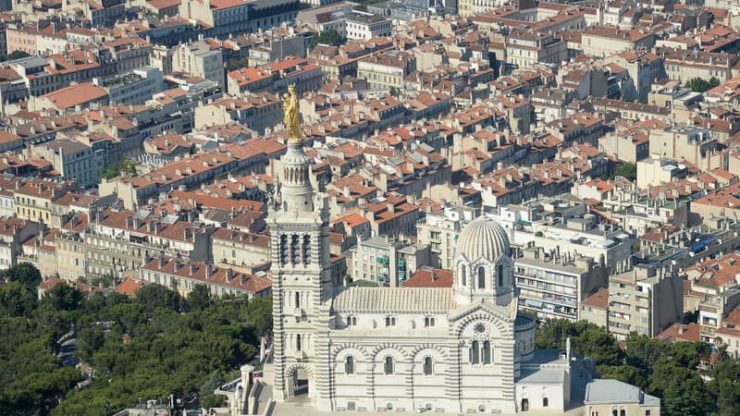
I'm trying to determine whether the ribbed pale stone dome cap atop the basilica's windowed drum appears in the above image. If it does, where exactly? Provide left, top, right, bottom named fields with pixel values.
left=457, top=214, right=511, bottom=262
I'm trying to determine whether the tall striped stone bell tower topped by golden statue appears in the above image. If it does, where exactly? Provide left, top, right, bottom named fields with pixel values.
left=268, top=87, right=334, bottom=406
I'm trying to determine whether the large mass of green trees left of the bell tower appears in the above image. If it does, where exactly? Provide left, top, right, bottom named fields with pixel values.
left=0, top=265, right=272, bottom=416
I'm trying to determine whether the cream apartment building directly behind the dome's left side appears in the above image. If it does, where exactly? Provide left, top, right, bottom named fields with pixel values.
left=416, top=206, right=478, bottom=269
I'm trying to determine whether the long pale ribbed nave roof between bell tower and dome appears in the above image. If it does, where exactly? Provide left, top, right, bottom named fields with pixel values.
left=334, top=287, right=457, bottom=313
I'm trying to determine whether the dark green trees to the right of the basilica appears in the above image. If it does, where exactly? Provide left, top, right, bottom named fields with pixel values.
left=536, top=320, right=740, bottom=416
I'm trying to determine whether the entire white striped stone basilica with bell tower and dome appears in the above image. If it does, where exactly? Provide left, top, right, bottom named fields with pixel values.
left=268, top=94, right=659, bottom=415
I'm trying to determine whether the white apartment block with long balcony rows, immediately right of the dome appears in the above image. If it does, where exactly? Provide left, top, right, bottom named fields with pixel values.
left=514, top=248, right=608, bottom=321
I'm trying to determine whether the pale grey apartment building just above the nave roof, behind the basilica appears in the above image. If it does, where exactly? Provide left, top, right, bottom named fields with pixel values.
left=350, top=237, right=432, bottom=287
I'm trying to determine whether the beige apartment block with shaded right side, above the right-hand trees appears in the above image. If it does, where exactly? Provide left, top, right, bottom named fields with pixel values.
left=608, top=268, right=683, bottom=340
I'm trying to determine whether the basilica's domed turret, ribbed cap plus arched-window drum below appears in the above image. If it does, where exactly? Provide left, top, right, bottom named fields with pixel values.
left=453, top=214, right=514, bottom=305
